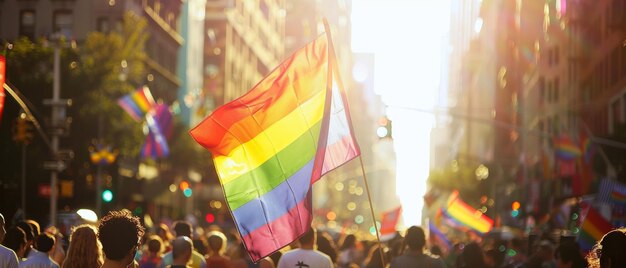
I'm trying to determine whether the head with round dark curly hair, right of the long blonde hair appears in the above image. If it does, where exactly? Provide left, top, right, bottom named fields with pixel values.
left=98, top=210, right=144, bottom=268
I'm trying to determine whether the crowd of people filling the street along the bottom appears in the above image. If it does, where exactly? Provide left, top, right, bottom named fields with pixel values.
left=0, top=210, right=626, bottom=268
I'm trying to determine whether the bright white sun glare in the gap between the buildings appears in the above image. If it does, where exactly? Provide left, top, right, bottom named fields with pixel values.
left=352, top=0, right=450, bottom=226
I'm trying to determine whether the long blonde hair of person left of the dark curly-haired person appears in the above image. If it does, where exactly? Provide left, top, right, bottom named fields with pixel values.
left=63, top=224, right=104, bottom=268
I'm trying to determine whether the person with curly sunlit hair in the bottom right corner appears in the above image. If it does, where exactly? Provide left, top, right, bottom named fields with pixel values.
left=586, top=228, right=626, bottom=268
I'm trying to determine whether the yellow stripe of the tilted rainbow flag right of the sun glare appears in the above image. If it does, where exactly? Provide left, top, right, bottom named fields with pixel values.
left=443, top=191, right=493, bottom=234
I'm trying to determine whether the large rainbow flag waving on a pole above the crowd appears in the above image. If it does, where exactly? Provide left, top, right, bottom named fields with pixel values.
left=190, top=32, right=360, bottom=262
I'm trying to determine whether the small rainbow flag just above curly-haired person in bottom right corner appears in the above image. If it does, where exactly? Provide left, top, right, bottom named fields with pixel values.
left=578, top=206, right=613, bottom=251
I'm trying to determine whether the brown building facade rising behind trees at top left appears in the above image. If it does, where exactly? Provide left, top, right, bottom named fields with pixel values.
left=0, top=0, right=183, bottom=103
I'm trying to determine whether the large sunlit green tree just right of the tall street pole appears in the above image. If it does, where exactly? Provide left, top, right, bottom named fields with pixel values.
left=72, top=12, right=148, bottom=155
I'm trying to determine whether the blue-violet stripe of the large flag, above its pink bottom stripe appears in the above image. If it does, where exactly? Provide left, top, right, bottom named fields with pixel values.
left=233, top=160, right=314, bottom=236
